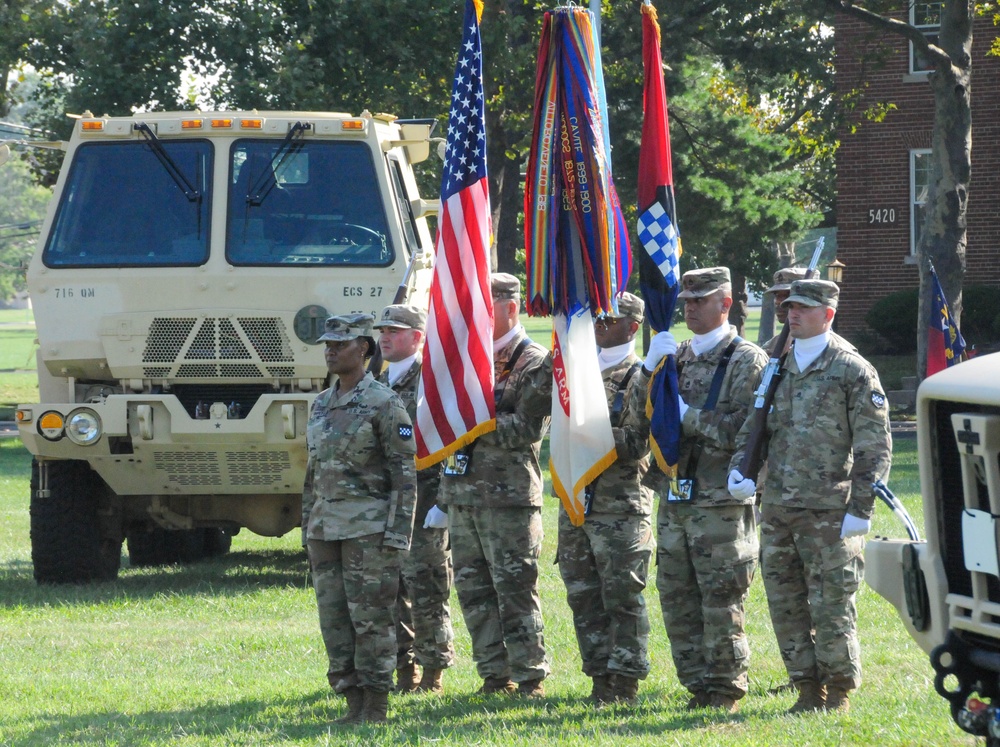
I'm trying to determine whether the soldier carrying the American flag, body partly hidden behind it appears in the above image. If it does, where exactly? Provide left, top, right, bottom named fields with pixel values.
left=438, top=273, right=552, bottom=697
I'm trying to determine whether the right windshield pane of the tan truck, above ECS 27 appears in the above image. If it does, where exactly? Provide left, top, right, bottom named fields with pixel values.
left=226, top=140, right=394, bottom=266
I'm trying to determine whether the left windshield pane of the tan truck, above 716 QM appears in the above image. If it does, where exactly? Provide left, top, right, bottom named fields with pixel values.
left=42, top=140, right=212, bottom=267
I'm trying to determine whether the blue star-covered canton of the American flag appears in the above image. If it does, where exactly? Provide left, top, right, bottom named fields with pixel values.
left=441, top=3, right=486, bottom=201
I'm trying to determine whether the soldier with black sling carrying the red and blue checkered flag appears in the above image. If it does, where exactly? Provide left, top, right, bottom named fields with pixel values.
left=640, top=267, right=767, bottom=713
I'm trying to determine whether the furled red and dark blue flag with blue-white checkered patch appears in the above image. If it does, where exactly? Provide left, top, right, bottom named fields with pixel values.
left=638, top=3, right=681, bottom=478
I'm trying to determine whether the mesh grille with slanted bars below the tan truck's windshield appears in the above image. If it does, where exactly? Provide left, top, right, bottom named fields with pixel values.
left=142, top=317, right=295, bottom=379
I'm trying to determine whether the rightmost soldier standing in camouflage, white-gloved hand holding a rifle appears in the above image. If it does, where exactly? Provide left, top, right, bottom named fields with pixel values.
left=729, top=280, right=892, bottom=713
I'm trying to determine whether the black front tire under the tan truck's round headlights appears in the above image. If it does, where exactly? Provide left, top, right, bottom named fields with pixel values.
left=30, top=459, right=122, bottom=584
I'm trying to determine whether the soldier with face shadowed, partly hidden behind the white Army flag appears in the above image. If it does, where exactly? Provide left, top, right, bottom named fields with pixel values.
left=558, top=293, right=654, bottom=706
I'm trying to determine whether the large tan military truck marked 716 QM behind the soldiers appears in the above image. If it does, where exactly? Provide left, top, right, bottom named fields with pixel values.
left=9, top=112, right=436, bottom=583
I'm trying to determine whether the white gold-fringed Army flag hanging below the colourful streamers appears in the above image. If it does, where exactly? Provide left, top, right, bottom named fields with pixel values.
left=549, top=309, right=618, bottom=526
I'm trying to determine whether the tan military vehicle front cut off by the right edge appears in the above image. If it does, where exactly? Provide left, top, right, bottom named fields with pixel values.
left=865, top=353, right=1000, bottom=747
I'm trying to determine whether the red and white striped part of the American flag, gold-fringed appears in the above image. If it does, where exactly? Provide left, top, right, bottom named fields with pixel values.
left=416, top=178, right=496, bottom=469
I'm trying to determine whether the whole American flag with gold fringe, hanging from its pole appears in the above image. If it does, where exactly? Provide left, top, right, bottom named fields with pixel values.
left=416, top=0, right=496, bottom=469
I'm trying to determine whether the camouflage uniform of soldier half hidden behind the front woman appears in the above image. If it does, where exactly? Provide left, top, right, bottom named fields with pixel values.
left=379, top=356, right=455, bottom=669
